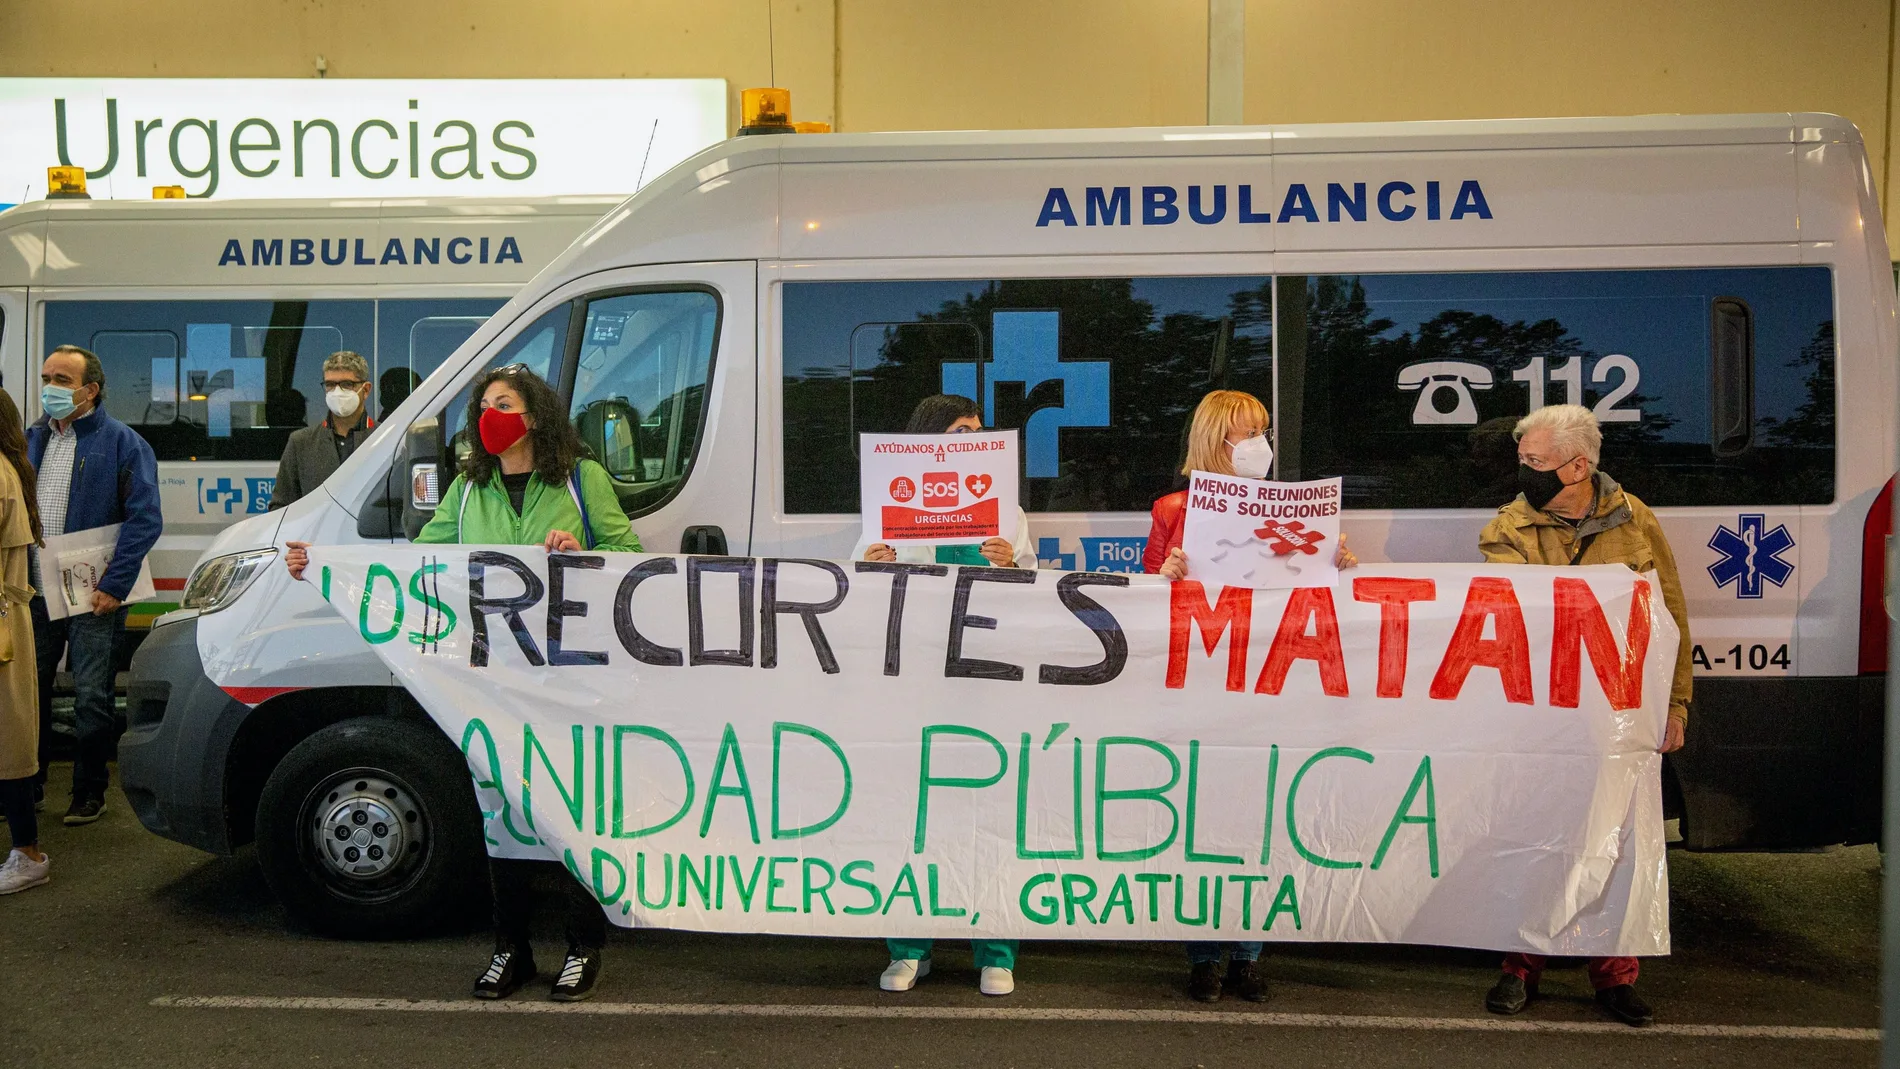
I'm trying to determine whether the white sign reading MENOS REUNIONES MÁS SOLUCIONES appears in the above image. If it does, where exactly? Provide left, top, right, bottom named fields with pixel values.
left=1182, top=471, right=1341, bottom=591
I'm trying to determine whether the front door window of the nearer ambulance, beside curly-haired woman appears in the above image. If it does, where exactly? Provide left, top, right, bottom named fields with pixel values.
left=570, top=289, right=720, bottom=516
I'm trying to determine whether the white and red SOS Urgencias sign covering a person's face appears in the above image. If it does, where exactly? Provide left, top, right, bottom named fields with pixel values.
left=857, top=431, right=1018, bottom=545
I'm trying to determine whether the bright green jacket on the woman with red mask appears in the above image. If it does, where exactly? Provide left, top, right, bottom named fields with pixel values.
left=416, top=459, right=640, bottom=553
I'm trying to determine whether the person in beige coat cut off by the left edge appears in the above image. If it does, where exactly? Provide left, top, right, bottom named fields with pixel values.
left=0, top=389, right=53, bottom=894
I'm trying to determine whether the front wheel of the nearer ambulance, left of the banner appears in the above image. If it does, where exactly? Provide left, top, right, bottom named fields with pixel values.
left=257, top=718, right=488, bottom=940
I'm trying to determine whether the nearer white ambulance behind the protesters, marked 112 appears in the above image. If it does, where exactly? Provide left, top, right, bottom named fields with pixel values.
left=122, top=114, right=1896, bottom=934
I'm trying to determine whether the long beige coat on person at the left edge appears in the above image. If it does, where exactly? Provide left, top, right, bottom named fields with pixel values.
left=0, top=458, right=40, bottom=780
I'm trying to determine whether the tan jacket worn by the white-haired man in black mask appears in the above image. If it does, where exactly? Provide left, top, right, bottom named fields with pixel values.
left=1478, top=471, right=1693, bottom=723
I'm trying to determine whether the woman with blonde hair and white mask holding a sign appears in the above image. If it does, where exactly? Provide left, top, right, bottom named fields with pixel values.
left=1142, top=389, right=1359, bottom=1003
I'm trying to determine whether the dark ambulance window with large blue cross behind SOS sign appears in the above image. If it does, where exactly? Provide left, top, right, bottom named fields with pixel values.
left=781, top=275, right=1273, bottom=515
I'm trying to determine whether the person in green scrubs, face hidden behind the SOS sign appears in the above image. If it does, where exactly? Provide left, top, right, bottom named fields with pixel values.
left=851, top=393, right=1036, bottom=995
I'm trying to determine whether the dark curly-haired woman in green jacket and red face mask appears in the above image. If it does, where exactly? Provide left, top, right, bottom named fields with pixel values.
left=285, top=365, right=640, bottom=1003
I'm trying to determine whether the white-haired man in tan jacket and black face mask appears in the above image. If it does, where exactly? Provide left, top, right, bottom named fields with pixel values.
left=1478, top=404, right=1691, bottom=1027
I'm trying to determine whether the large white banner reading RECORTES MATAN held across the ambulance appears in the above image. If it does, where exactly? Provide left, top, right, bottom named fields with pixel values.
left=310, top=545, right=1678, bottom=955
